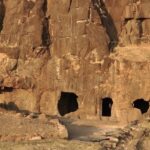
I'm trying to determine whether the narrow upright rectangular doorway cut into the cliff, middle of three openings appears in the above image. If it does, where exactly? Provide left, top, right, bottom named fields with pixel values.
left=102, top=97, right=113, bottom=117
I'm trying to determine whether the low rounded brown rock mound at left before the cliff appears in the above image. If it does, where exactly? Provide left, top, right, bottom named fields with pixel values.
left=0, top=109, right=68, bottom=142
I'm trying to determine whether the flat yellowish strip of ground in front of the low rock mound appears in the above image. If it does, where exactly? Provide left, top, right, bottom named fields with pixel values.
left=0, top=139, right=101, bottom=150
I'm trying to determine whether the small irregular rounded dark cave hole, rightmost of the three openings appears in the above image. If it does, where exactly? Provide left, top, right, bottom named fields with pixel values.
left=133, top=99, right=149, bottom=114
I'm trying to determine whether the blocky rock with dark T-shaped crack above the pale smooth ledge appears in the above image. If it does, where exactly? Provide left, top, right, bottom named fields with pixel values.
left=121, top=1, right=150, bottom=44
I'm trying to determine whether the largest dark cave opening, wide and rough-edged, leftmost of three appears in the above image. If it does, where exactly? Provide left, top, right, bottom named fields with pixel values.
left=58, top=92, right=78, bottom=116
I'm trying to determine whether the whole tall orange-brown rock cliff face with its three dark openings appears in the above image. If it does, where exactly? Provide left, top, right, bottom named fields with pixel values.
left=0, top=0, right=150, bottom=122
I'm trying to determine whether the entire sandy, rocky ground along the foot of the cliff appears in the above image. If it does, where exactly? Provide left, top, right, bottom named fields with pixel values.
left=0, top=109, right=150, bottom=150
